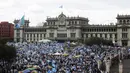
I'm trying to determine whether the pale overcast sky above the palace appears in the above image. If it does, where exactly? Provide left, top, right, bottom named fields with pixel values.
left=0, top=0, right=130, bottom=26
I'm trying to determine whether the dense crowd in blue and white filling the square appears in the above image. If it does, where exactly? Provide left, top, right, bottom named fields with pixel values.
left=1, top=41, right=126, bottom=73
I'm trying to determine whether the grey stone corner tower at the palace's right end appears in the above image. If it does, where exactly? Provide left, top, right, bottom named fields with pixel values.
left=116, top=15, right=130, bottom=46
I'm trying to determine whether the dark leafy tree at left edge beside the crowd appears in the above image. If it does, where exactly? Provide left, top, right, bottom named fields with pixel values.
left=0, top=39, right=16, bottom=73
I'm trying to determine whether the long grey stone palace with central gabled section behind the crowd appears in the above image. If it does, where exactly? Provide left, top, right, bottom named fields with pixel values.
left=14, top=13, right=130, bottom=46
